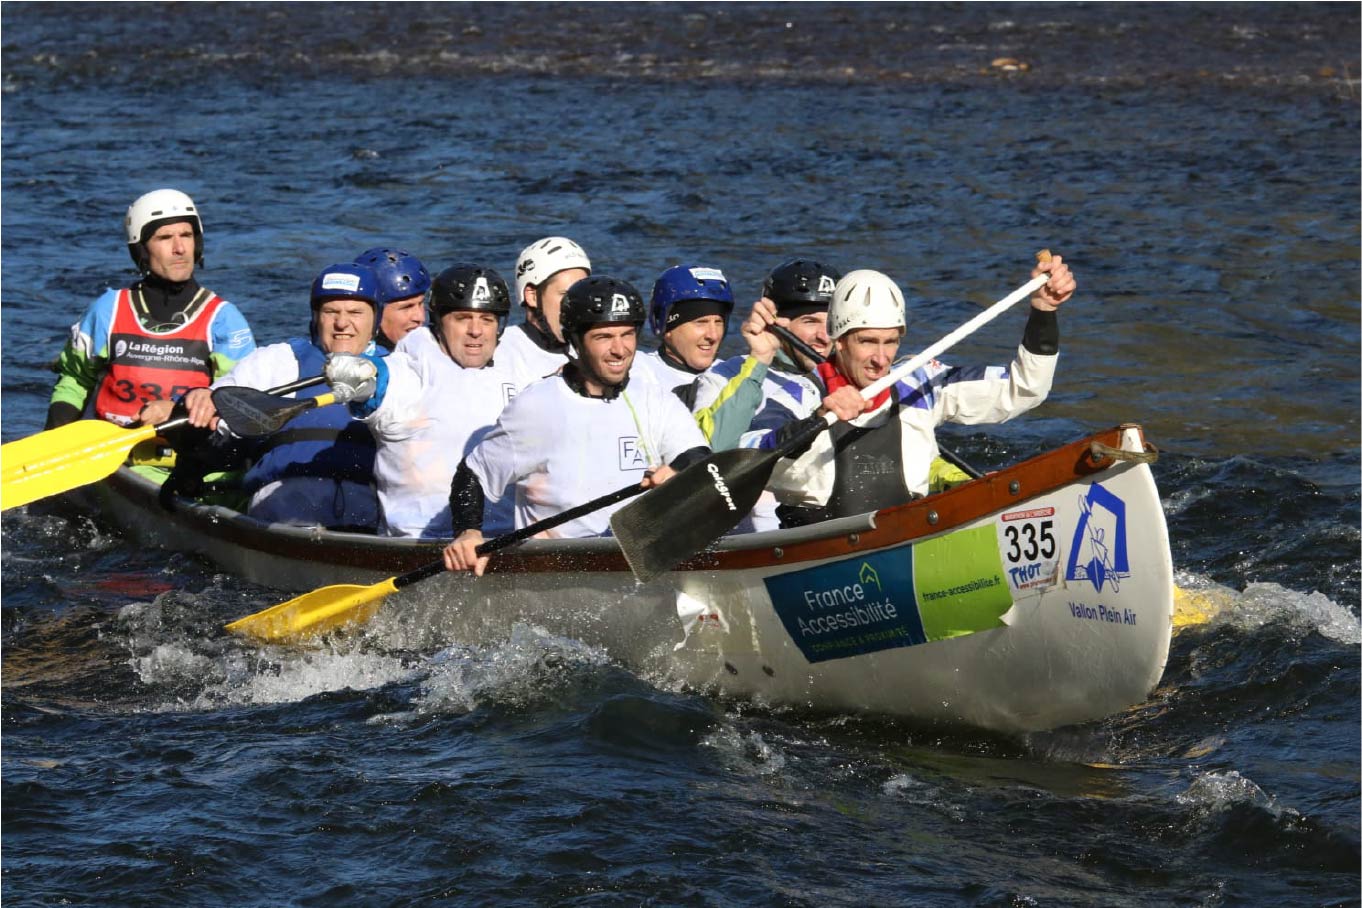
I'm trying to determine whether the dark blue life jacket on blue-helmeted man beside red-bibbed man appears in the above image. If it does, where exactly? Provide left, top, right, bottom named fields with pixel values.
left=245, top=338, right=376, bottom=491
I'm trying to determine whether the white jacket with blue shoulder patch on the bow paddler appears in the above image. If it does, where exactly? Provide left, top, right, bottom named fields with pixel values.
left=762, top=346, right=1058, bottom=508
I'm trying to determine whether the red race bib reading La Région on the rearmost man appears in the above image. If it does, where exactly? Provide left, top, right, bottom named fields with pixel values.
left=94, top=289, right=223, bottom=426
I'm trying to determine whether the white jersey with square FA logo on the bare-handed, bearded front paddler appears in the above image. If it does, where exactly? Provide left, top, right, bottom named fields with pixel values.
left=466, top=376, right=706, bottom=538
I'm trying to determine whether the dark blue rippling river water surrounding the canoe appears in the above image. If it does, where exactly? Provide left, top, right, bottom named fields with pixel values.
left=0, top=3, right=1362, bottom=905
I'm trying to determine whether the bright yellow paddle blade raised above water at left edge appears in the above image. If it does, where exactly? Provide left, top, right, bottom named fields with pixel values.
left=0, top=419, right=157, bottom=510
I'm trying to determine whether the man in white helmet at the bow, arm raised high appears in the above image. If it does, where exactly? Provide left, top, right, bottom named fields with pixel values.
left=742, top=256, right=1077, bottom=525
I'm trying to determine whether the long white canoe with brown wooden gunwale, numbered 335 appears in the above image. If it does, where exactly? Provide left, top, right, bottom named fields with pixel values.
left=85, top=425, right=1174, bottom=732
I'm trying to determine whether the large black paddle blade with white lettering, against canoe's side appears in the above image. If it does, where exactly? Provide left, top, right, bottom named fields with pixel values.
left=610, top=448, right=782, bottom=583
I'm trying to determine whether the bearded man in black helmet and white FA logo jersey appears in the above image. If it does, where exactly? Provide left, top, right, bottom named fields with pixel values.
left=444, top=276, right=710, bottom=574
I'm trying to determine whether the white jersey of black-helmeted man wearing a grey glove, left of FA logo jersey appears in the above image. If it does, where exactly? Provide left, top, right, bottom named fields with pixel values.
left=364, top=328, right=516, bottom=539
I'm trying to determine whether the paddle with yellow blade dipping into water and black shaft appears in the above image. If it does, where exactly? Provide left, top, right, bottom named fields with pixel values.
left=226, top=483, right=643, bottom=643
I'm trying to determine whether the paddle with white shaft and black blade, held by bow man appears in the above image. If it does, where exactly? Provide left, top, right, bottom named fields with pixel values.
left=610, top=266, right=1050, bottom=583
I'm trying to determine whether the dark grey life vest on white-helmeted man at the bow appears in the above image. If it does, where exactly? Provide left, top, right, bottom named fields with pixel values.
left=778, top=387, right=913, bottom=527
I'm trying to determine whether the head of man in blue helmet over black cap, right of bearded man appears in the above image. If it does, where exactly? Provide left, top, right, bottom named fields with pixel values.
left=636, top=265, right=733, bottom=407
